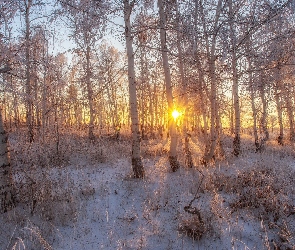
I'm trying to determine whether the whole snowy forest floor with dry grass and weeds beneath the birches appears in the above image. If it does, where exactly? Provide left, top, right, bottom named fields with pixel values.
left=0, top=133, right=295, bottom=250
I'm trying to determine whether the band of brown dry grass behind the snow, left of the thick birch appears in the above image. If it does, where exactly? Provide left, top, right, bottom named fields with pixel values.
left=9, top=129, right=135, bottom=169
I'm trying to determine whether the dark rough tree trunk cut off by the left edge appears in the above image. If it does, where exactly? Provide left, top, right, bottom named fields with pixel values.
left=0, top=110, right=15, bottom=213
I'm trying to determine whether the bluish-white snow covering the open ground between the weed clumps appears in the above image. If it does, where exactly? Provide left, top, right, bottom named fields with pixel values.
left=0, top=136, right=295, bottom=250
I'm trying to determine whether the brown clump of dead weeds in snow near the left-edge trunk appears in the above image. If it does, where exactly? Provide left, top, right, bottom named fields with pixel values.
left=14, top=167, right=78, bottom=226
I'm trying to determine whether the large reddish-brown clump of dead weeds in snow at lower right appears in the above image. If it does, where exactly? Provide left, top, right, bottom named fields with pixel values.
left=203, top=159, right=295, bottom=249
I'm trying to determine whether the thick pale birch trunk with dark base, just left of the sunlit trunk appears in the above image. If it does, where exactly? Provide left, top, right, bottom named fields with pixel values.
left=124, top=0, right=145, bottom=178
